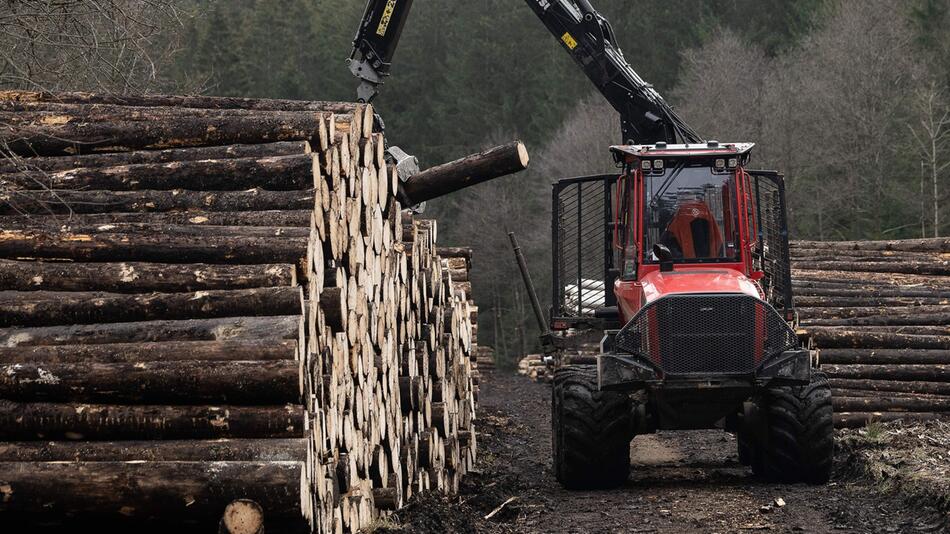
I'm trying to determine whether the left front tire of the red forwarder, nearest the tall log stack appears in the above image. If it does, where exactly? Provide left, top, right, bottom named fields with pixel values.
left=551, top=366, right=634, bottom=489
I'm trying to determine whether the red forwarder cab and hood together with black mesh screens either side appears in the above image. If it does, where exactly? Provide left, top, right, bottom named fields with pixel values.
left=551, top=141, right=793, bottom=330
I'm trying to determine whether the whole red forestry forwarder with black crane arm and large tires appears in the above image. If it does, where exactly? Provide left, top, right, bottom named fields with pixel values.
left=349, top=0, right=833, bottom=488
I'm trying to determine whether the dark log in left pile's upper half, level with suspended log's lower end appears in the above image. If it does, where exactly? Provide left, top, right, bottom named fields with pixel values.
left=0, top=189, right=313, bottom=215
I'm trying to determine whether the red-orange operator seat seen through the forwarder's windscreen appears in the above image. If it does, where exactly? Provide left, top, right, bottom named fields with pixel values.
left=660, top=200, right=723, bottom=259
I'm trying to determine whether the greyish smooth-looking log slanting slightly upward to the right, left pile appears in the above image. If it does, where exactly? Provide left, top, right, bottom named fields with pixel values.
left=0, top=315, right=300, bottom=347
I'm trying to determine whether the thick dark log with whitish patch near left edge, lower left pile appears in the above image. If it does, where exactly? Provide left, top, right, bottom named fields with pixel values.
left=0, top=360, right=301, bottom=405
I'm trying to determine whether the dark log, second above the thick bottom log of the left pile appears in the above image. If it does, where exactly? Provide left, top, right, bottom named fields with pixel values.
left=0, top=399, right=304, bottom=441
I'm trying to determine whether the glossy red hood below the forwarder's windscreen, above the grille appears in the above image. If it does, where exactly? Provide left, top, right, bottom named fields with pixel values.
left=640, top=265, right=762, bottom=304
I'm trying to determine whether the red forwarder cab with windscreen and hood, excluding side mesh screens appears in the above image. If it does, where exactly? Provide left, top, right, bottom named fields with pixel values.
left=611, top=141, right=765, bottom=321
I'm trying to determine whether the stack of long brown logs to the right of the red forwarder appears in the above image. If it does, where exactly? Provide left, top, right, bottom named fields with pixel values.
left=791, top=238, right=950, bottom=427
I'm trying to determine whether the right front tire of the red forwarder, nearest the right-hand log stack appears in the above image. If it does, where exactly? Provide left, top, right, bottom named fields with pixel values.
left=753, top=372, right=834, bottom=484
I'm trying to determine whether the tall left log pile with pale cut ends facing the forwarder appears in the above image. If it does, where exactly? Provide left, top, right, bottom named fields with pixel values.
left=0, top=92, right=527, bottom=532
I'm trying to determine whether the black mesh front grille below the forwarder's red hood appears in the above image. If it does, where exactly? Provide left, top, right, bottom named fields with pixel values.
left=616, top=294, right=798, bottom=376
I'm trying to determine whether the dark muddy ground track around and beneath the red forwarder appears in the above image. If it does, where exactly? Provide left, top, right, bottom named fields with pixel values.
left=380, top=373, right=947, bottom=533
